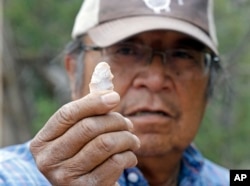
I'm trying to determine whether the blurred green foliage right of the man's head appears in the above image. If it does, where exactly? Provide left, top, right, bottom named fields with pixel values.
left=195, top=0, right=250, bottom=169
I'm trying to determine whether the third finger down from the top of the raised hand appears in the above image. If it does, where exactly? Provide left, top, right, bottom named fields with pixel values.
left=63, top=131, right=140, bottom=174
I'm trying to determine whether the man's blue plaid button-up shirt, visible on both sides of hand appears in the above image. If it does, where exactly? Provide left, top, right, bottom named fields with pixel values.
left=0, top=142, right=229, bottom=186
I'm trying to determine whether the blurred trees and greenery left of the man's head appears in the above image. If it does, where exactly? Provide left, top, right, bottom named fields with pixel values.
left=3, top=0, right=82, bottom=145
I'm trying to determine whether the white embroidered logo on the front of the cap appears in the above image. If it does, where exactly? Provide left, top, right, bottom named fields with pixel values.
left=143, top=0, right=184, bottom=14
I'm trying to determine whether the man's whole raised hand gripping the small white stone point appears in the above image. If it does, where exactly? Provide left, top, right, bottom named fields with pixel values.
left=30, top=87, right=140, bottom=186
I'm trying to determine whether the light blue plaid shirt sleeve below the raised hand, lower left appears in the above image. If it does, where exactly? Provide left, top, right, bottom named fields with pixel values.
left=0, top=142, right=49, bottom=186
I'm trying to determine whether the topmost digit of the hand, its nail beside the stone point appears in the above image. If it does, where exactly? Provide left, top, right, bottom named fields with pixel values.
left=32, top=91, right=120, bottom=142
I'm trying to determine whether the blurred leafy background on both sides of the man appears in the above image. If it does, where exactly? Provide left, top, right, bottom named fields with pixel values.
left=2, top=0, right=250, bottom=169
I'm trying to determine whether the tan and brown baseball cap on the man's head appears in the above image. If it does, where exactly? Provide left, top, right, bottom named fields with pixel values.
left=72, top=0, right=218, bottom=54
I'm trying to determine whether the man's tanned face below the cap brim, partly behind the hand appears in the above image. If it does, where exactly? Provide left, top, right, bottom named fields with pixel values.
left=68, top=31, right=208, bottom=156
